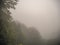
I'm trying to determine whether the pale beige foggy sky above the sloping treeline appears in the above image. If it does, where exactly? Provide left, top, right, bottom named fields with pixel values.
left=11, top=0, right=59, bottom=39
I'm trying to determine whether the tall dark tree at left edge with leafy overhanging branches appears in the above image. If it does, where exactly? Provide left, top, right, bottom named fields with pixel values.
left=0, top=0, right=17, bottom=45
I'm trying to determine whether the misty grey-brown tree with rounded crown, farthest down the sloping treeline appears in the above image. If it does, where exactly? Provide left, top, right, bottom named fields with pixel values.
left=29, top=27, right=42, bottom=45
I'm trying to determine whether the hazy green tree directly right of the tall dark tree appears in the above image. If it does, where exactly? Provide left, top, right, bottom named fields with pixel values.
left=9, top=21, right=24, bottom=45
